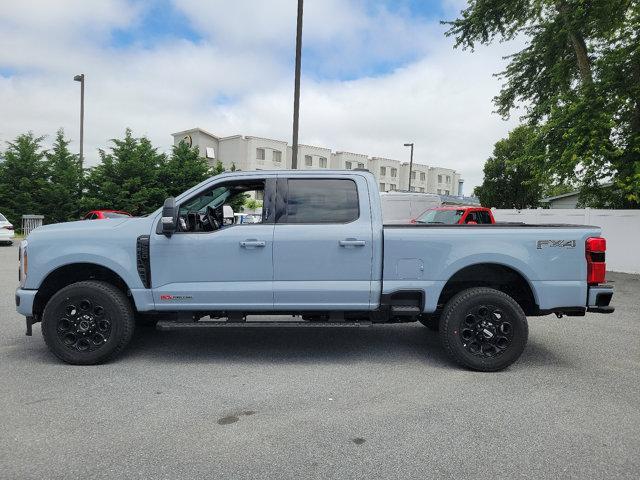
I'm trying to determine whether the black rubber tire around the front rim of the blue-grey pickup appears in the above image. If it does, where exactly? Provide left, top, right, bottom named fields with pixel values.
left=42, top=280, right=135, bottom=365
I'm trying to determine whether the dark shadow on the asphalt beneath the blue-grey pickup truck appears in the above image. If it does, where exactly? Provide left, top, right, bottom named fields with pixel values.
left=121, top=324, right=570, bottom=369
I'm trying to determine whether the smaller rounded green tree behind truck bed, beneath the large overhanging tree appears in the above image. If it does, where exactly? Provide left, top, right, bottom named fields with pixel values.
left=473, top=126, right=547, bottom=209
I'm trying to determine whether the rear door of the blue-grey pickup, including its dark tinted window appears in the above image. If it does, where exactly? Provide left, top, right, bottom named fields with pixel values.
left=273, top=175, right=373, bottom=310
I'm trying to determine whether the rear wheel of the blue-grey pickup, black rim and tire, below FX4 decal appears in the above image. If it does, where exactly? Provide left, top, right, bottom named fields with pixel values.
left=440, top=287, right=529, bottom=372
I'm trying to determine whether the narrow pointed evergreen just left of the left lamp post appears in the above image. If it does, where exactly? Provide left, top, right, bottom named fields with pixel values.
left=45, top=129, right=82, bottom=223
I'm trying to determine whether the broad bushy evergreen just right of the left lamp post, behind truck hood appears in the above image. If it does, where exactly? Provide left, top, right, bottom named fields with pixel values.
left=83, top=129, right=171, bottom=215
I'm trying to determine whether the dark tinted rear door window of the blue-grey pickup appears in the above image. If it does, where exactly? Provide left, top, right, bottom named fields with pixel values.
left=279, top=179, right=360, bottom=223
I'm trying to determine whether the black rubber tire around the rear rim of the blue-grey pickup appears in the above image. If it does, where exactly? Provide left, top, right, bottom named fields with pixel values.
left=440, top=287, right=529, bottom=372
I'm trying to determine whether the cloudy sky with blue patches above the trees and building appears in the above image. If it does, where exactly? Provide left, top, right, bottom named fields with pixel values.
left=0, top=0, right=514, bottom=192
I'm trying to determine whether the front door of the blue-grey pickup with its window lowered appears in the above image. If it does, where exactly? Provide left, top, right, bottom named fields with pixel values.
left=150, top=178, right=275, bottom=311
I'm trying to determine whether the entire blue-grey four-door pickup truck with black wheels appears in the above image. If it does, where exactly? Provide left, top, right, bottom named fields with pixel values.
left=16, top=170, right=613, bottom=371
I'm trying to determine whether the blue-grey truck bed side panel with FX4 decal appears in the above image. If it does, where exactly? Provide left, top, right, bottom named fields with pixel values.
left=382, top=224, right=600, bottom=312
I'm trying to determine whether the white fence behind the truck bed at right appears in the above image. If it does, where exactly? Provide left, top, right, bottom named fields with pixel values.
left=493, top=208, right=640, bottom=273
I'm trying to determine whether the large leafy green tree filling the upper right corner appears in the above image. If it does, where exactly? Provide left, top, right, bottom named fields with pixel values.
left=445, top=0, right=640, bottom=207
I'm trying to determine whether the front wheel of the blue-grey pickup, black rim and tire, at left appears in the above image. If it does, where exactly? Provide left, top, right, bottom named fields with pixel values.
left=42, top=281, right=135, bottom=365
